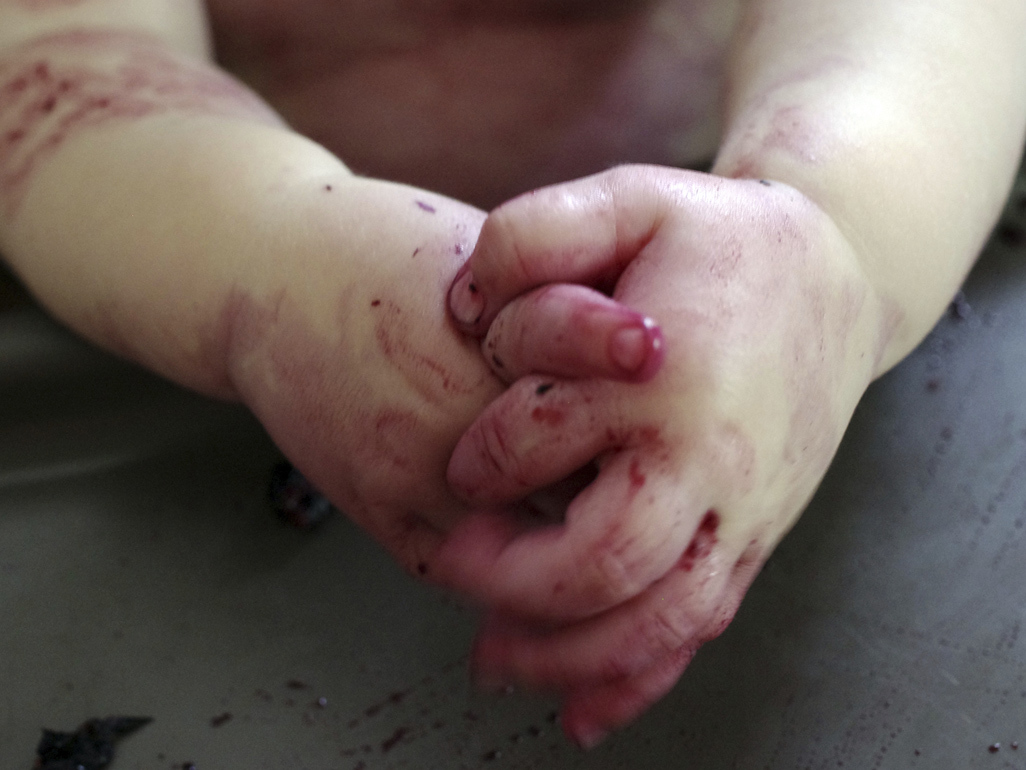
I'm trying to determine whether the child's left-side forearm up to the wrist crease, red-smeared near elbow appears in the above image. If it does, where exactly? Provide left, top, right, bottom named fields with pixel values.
left=0, top=10, right=309, bottom=398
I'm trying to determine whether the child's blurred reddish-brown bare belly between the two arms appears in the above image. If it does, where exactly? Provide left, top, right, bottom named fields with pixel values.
left=209, top=0, right=737, bottom=206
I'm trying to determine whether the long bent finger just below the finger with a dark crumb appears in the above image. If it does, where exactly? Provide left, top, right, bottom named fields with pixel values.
left=436, top=450, right=707, bottom=621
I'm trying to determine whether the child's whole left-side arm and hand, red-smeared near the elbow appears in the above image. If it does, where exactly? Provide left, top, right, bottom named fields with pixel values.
left=0, top=0, right=500, bottom=569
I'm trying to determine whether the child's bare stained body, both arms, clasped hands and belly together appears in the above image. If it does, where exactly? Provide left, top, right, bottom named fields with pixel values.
left=0, top=0, right=1026, bottom=745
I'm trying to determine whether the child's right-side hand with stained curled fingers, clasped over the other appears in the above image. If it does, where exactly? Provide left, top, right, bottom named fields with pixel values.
left=433, top=166, right=885, bottom=744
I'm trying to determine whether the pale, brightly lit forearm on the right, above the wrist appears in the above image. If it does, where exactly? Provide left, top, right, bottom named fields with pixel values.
left=713, top=0, right=1026, bottom=374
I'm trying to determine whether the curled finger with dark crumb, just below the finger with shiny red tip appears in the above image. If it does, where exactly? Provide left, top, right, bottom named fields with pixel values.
left=447, top=377, right=624, bottom=505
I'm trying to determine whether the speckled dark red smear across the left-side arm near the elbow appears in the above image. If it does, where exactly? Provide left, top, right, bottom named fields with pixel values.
left=0, top=29, right=281, bottom=216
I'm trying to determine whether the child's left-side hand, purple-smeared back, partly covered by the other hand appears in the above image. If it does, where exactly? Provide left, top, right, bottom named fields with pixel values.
left=214, top=179, right=502, bottom=574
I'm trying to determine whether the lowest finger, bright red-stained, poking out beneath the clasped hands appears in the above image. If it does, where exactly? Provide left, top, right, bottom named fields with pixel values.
left=562, top=648, right=695, bottom=748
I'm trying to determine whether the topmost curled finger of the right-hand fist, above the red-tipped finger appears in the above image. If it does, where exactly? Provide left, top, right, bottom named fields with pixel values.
left=448, top=166, right=668, bottom=336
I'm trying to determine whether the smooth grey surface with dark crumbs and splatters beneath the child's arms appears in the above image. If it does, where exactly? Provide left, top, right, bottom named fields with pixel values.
left=0, top=177, right=1026, bottom=770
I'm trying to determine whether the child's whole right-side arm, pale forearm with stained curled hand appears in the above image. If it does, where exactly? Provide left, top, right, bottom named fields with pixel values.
left=438, top=0, right=1026, bottom=744
